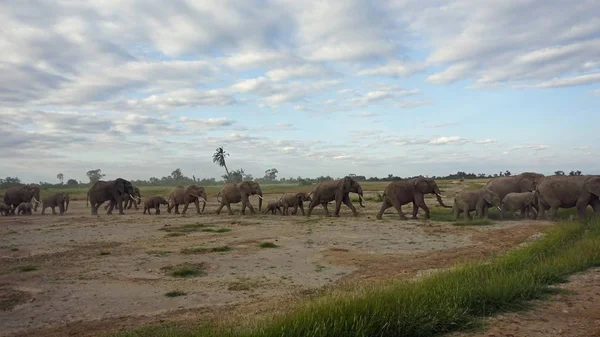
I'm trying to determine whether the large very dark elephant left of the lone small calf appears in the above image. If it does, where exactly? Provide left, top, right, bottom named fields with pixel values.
left=86, top=178, right=133, bottom=215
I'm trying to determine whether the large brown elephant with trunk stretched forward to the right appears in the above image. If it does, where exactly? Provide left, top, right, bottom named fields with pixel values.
left=377, top=177, right=452, bottom=220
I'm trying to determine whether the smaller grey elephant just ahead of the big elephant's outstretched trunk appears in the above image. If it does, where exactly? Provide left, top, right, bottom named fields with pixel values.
left=452, top=187, right=502, bottom=220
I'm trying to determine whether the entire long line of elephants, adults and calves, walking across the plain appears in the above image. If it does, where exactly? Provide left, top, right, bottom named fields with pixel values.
left=0, top=172, right=600, bottom=220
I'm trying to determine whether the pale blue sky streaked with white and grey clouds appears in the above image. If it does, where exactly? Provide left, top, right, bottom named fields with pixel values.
left=0, top=0, right=600, bottom=182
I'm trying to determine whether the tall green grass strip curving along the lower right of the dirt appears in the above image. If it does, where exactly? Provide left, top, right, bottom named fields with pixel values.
left=110, top=221, right=600, bottom=337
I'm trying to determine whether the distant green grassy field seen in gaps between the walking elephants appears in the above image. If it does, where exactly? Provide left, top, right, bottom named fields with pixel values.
left=0, top=179, right=489, bottom=201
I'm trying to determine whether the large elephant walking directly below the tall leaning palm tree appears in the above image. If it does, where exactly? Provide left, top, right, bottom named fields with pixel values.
left=216, top=181, right=263, bottom=215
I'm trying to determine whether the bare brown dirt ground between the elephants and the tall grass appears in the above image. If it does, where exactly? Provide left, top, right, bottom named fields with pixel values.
left=0, top=188, right=600, bottom=336
